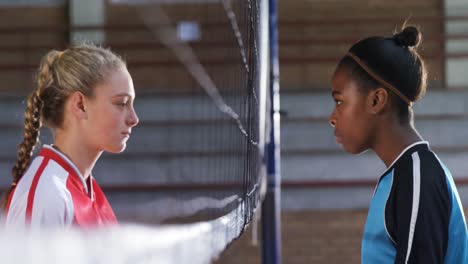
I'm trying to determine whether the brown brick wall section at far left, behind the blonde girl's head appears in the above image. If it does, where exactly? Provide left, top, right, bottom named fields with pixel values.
left=0, top=6, right=68, bottom=94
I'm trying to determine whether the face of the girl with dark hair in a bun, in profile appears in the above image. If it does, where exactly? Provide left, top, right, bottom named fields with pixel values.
left=329, top=69, right=375, bottom=154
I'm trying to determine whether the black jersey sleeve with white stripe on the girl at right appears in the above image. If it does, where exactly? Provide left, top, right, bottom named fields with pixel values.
left=386, top=152, right=450, bottom=264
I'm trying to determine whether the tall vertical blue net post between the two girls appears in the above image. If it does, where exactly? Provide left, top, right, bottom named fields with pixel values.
left=262, top=0, right=281, bottom=264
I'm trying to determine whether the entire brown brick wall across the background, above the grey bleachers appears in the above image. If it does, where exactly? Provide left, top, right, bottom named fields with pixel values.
left=0, top=0, right=444, bottom=93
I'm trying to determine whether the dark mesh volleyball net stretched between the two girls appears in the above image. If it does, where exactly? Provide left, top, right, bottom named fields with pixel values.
left=102, top=1, right=267, bottom=227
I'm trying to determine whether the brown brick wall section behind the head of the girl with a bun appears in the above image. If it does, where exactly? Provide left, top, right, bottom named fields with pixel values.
left=278, top=0, right=443, bottom=90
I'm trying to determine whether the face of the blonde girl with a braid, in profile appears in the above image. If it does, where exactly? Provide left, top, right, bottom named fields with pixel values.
left=83, top=66, right=138, bottom=153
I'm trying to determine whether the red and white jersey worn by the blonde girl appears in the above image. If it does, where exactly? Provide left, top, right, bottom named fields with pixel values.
left=6, top=145, right=117, bottom=227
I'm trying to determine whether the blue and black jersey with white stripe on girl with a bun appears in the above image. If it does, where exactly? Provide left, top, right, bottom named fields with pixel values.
left=361, top=142, right=468, bottom=264
